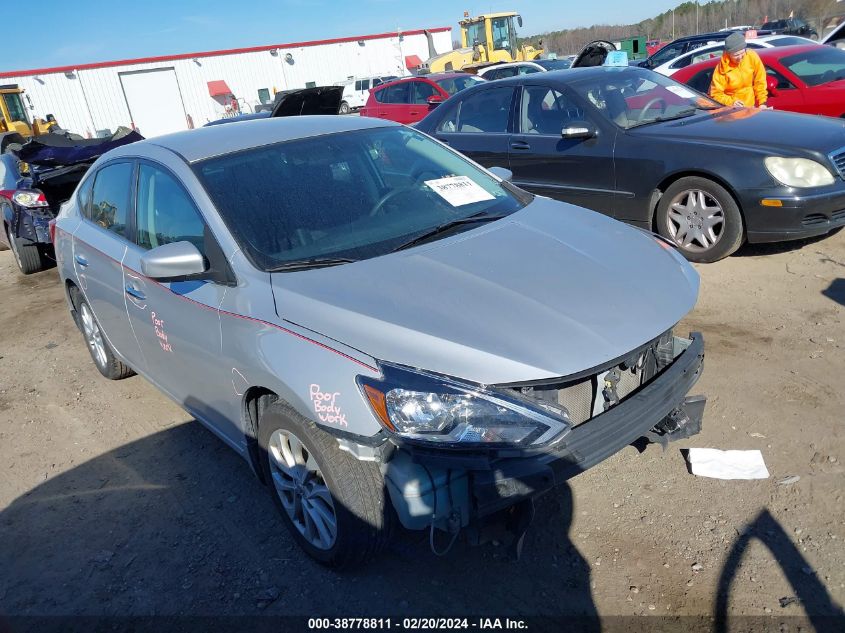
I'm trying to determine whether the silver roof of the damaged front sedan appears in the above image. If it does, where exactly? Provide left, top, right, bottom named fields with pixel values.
left=108, top=115, right=399, bottom=163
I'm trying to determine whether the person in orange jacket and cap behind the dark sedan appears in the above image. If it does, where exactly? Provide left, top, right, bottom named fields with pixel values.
left=710, top=33, right=769, bottom=108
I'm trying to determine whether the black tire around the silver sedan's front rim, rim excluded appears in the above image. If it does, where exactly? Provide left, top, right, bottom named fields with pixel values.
left=258, top=403, right=396, bottom=568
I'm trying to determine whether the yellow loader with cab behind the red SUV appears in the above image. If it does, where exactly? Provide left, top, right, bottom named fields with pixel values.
left=418, top=12, right=543, bottom=74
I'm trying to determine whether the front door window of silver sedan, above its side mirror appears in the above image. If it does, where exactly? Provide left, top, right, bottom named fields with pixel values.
left=136, top=164, right=205, bottom=253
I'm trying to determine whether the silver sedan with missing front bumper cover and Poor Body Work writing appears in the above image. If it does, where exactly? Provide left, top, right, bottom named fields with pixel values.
left=55, top=117, right=704, bottom=565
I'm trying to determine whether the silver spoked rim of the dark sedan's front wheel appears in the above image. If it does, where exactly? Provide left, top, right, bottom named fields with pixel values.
left=666, top=189, right=725, bottom=252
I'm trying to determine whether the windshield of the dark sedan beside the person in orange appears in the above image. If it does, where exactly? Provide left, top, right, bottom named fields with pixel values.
left=568, top=68, right=721, bottom=129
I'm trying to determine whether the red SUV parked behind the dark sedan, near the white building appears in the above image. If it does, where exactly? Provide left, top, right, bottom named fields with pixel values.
left=360, top=73, right=484, bottom=123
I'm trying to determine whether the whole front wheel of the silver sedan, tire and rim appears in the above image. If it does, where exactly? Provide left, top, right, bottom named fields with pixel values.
left=259, top=404, right=394, bottom=568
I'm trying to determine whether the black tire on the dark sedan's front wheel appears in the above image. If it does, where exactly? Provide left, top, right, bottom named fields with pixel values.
left=654, top=176, right=745, bottom=263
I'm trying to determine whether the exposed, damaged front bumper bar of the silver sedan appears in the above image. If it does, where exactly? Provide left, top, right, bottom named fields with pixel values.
left=383, top=333, right=705, bottom=532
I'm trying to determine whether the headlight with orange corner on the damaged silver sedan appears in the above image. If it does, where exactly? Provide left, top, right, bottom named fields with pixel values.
left=358, top=363, right=571, bottom=448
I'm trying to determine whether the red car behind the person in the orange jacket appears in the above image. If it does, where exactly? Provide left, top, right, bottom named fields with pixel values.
left=672, top=44, right=845, bottom=117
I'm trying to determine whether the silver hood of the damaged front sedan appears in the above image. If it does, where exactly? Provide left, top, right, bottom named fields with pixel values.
left=271, top=198, right=698, bottom=384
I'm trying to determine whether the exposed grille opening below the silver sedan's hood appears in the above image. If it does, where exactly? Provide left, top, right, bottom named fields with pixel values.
left=507, top=330, right=674, bottom=425
